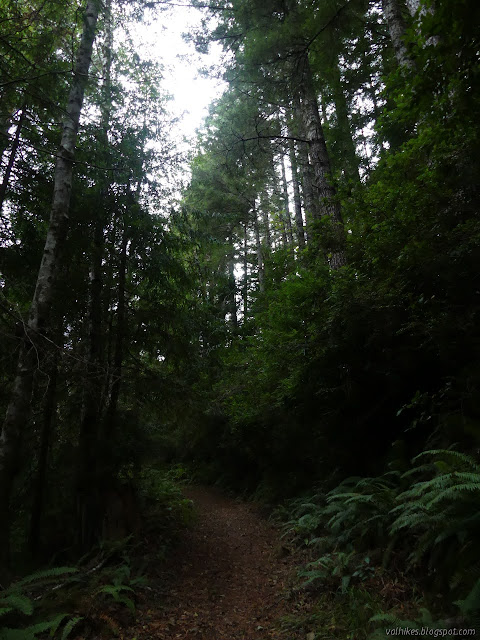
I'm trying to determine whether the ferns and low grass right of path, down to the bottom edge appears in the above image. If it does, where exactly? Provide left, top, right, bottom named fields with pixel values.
left=275, top=449, right=480, bottom=640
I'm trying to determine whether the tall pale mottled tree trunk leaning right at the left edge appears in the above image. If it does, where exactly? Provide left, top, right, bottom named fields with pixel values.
left=0, top=0, right=99, bottom=567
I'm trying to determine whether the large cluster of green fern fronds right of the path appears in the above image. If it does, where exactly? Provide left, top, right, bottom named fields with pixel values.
left=285, top=450, right=480, bottom=613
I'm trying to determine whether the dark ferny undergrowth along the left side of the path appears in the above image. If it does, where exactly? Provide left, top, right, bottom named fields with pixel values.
left=0, top=467, right=194, bottom=640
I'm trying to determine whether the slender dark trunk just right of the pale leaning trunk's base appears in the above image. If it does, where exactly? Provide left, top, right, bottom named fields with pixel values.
left=28, top=350, right=59, bottom=559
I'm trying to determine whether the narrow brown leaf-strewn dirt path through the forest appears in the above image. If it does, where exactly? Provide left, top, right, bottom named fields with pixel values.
left=128, top=487, right=308, bottom=640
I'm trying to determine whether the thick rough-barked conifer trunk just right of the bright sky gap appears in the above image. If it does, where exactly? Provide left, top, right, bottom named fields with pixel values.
left=300, top=54, right=346, bottom=269
